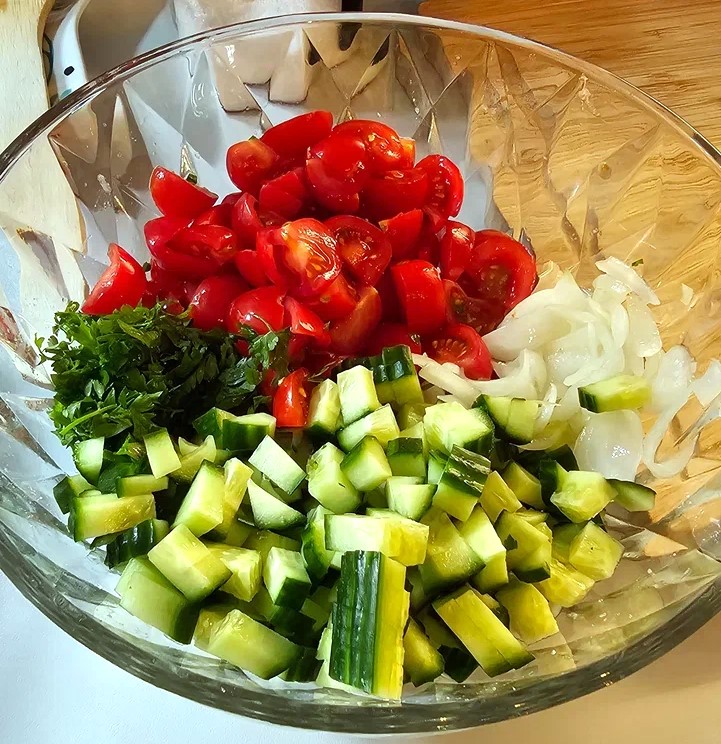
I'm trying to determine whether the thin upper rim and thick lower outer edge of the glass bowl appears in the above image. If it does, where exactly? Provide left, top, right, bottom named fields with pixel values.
left=0, top=13, right=721, bottom=734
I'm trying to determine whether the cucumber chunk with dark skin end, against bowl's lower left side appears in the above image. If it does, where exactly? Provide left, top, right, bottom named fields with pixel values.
left=116, top=557, right=200, bottom=643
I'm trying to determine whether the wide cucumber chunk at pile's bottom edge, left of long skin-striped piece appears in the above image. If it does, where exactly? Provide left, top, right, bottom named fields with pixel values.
left=208, top=610, right=301, bottom=679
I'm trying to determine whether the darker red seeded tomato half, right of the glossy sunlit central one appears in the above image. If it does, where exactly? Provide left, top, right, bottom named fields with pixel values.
left=325, top=215, right=393, bottom=287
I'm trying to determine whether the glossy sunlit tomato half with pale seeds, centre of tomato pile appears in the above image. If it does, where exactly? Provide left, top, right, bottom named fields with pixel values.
left=275, top=217, right=341, bottom=298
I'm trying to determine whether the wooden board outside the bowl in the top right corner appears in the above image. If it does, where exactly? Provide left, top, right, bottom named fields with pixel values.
left=421, top=0, right=721, bottom=147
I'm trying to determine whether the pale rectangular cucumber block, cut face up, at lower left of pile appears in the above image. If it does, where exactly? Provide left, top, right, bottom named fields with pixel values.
left=148, top=524, right=232, bottom=602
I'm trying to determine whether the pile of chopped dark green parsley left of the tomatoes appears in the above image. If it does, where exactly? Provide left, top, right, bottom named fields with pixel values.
left=37, top=302, right=288, bottom=445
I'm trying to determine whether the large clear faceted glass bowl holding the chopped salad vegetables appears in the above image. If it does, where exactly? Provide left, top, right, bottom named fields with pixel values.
left=0, top=14, right=721, bottom=733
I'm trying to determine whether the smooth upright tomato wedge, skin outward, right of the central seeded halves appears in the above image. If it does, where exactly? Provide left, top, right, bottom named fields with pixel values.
left=391, top=260, right=446, bottom=334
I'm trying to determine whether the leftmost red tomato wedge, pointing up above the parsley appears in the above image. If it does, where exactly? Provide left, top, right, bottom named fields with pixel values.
left=82, top=243, right=148, bottom=315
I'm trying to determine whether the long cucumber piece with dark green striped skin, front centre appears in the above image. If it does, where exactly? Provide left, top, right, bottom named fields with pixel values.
left=329, top=548, right=409, bottom=700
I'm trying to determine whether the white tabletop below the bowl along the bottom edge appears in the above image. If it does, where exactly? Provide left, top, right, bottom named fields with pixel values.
left=0, top=574, right=721, bottom=744
